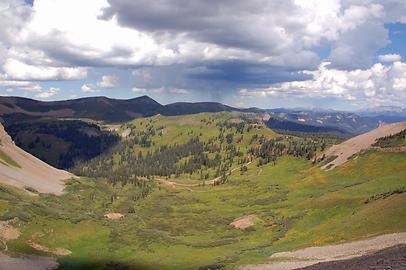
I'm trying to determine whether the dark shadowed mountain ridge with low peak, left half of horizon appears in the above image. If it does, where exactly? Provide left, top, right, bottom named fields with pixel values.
left=0, top=96, right=239, bottom=122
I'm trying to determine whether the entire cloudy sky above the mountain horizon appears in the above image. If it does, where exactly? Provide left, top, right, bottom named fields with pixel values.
left=0, top=0, right=406, bottom=110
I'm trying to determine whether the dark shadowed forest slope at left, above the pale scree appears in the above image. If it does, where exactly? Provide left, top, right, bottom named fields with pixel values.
left=5, top=118, right=119, bottom=169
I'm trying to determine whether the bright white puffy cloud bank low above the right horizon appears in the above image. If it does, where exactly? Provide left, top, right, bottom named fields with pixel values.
left=239, top=62, right=406, bottom=105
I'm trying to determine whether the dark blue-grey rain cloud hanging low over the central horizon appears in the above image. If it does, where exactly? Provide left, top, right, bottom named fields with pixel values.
left=133, top=61, right=310, bottom=100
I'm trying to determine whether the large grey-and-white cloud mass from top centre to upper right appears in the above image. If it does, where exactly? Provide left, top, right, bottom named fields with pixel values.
left=100, top=0, right=406, bottom=67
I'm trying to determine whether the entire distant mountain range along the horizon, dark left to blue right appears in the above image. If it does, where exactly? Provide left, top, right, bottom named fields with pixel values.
left=0, top=96, right=406, bottom=135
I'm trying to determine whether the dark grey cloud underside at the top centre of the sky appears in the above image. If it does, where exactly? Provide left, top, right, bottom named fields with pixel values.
left=100, top=0, right=301, bottom=52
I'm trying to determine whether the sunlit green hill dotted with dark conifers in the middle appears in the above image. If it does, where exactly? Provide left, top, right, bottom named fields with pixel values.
left=72, top=110, right=334, bottom=189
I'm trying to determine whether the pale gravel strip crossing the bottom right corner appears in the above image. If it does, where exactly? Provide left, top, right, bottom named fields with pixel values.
left=238, top=233, right=406, bottom=270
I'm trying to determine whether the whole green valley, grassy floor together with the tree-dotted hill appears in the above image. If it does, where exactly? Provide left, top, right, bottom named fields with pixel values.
left=0, top=110, right=406, bottom=269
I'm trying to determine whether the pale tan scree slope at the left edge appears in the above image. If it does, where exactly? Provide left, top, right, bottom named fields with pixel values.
left=0, top=124, right=74, bottom=194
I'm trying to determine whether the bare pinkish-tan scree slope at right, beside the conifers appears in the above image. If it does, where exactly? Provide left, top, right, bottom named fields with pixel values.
left=322, top=122, right=406, bottom=170
